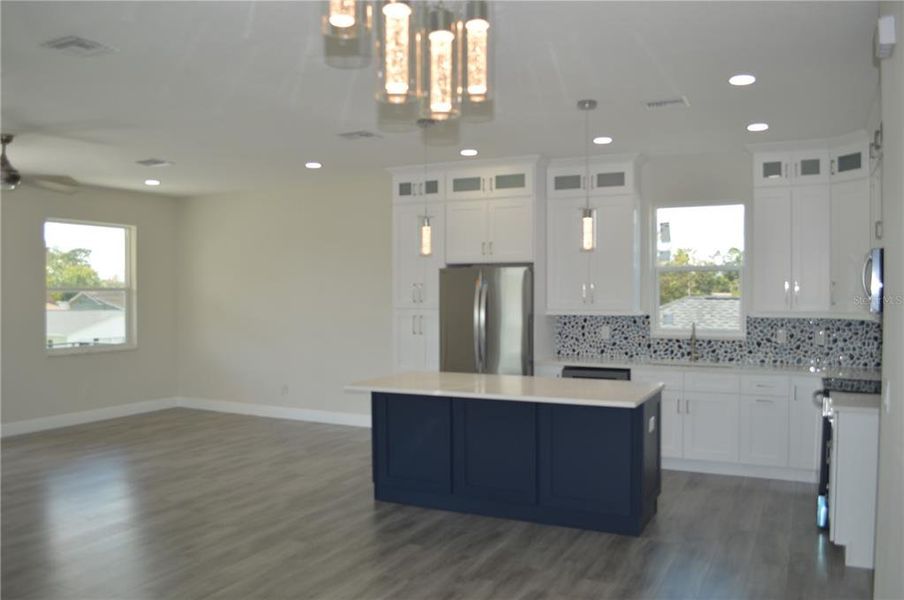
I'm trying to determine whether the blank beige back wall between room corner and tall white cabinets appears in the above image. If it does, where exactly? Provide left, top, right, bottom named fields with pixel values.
left=178, top=169, right=392, bottom=414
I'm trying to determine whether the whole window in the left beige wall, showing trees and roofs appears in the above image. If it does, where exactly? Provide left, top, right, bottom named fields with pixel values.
left=44, top=221, right=135, bottom=353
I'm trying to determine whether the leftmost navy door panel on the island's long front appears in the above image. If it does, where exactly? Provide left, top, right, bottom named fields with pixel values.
left=373, top=394, right=452, bottom=494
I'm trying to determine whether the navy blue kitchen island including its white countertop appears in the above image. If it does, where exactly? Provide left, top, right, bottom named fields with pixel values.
left=350, top=373, right=661, bottom=535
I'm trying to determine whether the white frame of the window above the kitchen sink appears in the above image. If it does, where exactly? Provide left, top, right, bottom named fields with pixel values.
left=647, top=199, right=750, bottom=340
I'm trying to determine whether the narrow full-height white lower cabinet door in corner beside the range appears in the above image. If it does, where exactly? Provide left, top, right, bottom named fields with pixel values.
left=788, top=377, right=822, bottom=471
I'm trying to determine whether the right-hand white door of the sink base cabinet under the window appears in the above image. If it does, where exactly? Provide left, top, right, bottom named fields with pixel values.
left=684, top=391, right=738, bottom=462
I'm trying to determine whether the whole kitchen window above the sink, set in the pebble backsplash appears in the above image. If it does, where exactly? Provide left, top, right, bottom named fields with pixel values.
left=654, top=204, right=744, bottom=337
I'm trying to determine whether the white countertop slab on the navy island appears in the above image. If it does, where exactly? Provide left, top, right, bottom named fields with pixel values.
left=345, top=373, right=663, bottom=408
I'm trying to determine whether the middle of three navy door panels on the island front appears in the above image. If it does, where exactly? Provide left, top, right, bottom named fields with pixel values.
left=453, top=399, right=537, bottom=504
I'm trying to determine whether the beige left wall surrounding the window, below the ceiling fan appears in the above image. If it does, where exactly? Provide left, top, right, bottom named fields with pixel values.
left=0, top=186, right=176, bottom=423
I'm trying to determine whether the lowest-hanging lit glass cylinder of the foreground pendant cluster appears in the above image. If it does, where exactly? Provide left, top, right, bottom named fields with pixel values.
left=421, top=5, right=462, bottom=121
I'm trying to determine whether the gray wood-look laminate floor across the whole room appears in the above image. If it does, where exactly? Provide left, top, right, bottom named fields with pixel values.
left=2, top=409, right=872, bottom=599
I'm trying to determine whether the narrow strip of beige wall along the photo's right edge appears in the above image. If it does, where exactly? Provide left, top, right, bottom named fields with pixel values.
left=874, top=2, right=904, bottom=599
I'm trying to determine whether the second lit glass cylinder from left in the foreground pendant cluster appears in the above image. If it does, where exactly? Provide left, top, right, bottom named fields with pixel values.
left=376, top=0, right=417, bottom=104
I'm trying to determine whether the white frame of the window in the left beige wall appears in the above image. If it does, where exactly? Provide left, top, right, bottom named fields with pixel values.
left=41, top=217, right=138, bottom=356
